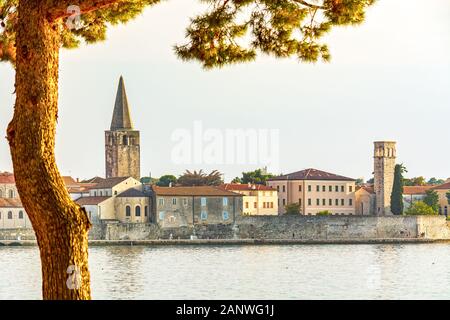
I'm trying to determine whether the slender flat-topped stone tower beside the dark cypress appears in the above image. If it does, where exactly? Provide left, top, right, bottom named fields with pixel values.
left=374, top=141, right=397, bottom=215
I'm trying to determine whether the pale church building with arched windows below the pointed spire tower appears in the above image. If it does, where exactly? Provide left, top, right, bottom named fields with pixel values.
left=76, top=177, right=151, bottom=223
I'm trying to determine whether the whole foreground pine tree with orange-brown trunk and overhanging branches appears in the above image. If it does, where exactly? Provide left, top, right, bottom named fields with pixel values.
left=0, top=0, right=374, bottom=299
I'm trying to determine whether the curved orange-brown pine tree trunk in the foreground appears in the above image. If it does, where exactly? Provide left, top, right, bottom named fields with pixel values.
left=8, top=0, right=91, bottom=299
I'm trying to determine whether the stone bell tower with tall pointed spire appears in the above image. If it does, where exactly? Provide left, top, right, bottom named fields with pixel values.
left=105, top=76, right=141, bottom=180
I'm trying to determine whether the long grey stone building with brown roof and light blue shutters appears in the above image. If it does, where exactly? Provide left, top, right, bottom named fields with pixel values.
left=152, top=186, right=242, bottom=228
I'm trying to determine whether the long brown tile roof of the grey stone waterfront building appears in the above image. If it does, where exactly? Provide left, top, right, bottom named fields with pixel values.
left=152, top=186, right=242, bottom=197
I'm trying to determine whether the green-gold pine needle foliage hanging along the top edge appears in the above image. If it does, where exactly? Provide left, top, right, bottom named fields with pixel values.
left=0, top=0, right=375, bottom=68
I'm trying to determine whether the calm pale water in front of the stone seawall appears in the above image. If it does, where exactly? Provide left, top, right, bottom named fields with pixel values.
left=0, top=244, right=450, bottom=299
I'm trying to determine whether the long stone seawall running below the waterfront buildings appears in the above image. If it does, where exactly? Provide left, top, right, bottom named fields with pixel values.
left=0, top=216, right=450, bottom=241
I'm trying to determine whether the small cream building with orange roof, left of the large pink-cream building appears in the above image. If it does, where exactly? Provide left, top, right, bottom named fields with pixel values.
left=220, top=183, right=278, bottom=216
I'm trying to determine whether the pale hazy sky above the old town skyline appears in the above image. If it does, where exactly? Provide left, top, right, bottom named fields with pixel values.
left=0, top=0, right=450, bottom=180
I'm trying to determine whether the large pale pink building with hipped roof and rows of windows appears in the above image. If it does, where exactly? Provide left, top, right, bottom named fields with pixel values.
left=267, top=169, right=356, bottom=215
